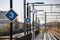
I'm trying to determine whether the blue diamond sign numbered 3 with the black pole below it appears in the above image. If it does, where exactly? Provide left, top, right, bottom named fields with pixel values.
left=6, top=9, right=18, bottom=40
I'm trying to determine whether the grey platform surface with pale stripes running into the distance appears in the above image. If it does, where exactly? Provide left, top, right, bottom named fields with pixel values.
left=34, top=32, right=57, bottom=40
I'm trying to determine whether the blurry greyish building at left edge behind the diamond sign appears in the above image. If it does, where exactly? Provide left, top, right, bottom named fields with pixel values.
left=0, top=11, right=9, bottom=30
